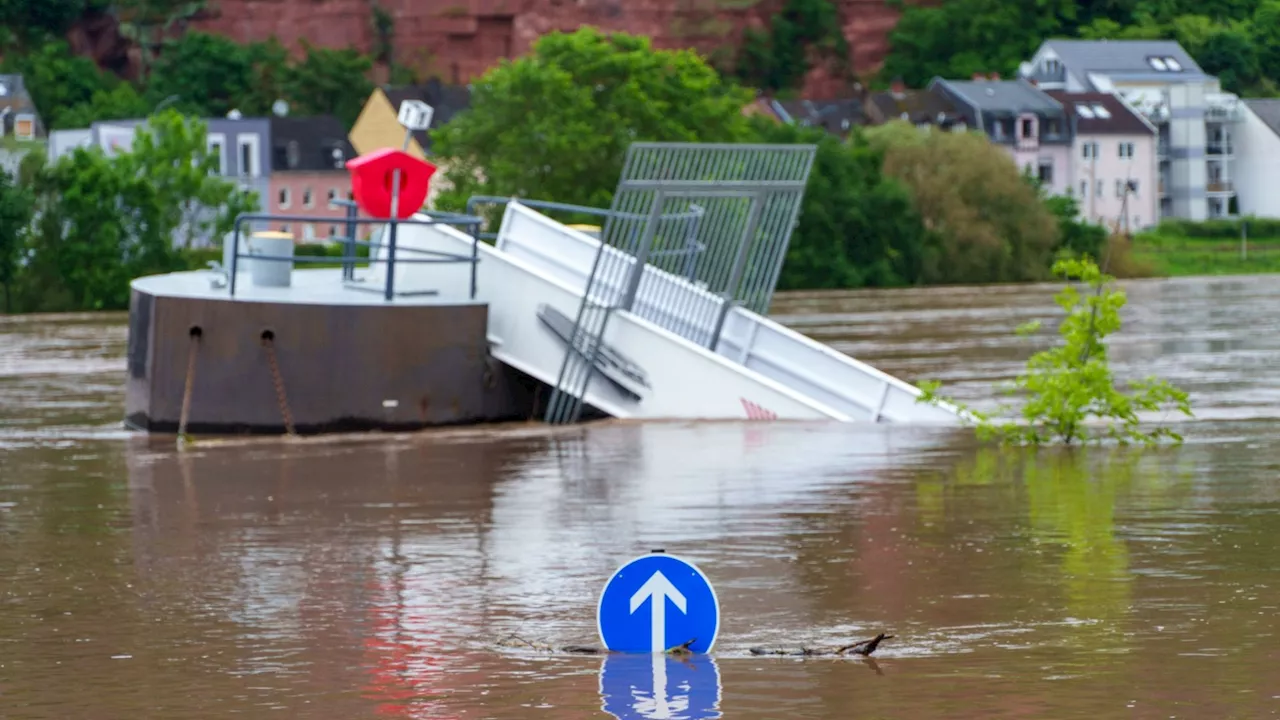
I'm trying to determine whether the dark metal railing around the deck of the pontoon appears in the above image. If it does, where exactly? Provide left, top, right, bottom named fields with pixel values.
left=227, top=207, right=483, bottom=301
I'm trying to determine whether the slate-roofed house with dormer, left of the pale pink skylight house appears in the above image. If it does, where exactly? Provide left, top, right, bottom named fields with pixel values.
left=929, top=76, right=1074, bottom=195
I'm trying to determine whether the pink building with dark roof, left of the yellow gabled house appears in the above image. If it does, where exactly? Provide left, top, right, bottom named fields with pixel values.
left=262, top=115, right=356, bottom=242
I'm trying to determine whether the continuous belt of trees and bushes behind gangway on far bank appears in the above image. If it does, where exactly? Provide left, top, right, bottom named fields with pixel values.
left=435, top=28, right=1106, bottom=290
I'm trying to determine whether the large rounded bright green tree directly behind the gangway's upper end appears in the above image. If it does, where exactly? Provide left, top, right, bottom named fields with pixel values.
left=433, top=27, right=751, bottom=209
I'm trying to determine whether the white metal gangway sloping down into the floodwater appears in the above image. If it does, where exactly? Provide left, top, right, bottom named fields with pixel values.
left=367, top=201, right=959, bottom=424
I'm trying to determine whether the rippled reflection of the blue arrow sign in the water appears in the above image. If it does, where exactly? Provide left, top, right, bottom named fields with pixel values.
left=600, top=655, right=722, bottom=720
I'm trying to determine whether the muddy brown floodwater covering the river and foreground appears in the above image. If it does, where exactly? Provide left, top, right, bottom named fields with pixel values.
left=0, top=271, right=1280, bottom=720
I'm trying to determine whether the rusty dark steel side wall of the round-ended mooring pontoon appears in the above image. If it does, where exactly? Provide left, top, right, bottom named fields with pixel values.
left=125, top=292, right=531, bottom=433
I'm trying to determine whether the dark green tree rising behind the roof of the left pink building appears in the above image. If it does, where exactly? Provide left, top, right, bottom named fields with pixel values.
left=284, top=41, right=374, bottom=127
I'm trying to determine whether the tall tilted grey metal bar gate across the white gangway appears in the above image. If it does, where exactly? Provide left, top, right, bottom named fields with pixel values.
left=545, top=142, right=817, bottom=424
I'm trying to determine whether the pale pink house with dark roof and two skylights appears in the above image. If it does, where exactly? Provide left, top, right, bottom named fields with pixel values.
left=1047, top=90, right=1164, bottom=232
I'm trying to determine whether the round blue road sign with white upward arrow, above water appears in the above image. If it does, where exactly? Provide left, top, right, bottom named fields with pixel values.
left=595, top=552, right=719, bottom=652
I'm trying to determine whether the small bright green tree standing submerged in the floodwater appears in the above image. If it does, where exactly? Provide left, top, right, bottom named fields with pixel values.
left=919, top=252, right=1192, bottom=445
